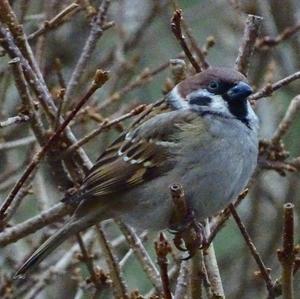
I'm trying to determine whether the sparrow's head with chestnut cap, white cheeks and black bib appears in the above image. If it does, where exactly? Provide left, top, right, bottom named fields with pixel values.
left=168, top=67, right=256, bottom=126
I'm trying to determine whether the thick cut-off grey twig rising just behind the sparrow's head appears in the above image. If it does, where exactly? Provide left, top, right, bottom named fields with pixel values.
left=235, top=15, right=263, bottom=75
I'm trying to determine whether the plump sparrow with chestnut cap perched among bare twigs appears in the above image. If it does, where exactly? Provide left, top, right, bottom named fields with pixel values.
left=15, top=67, right=259, bottom=277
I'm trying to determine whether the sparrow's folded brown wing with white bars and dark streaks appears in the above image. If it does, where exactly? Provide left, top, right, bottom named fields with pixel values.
left=74, top=111, right=197, bottom=201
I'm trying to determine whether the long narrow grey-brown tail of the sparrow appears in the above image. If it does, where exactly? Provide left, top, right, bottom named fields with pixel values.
left=14, top=209, right=101, bottom=279
